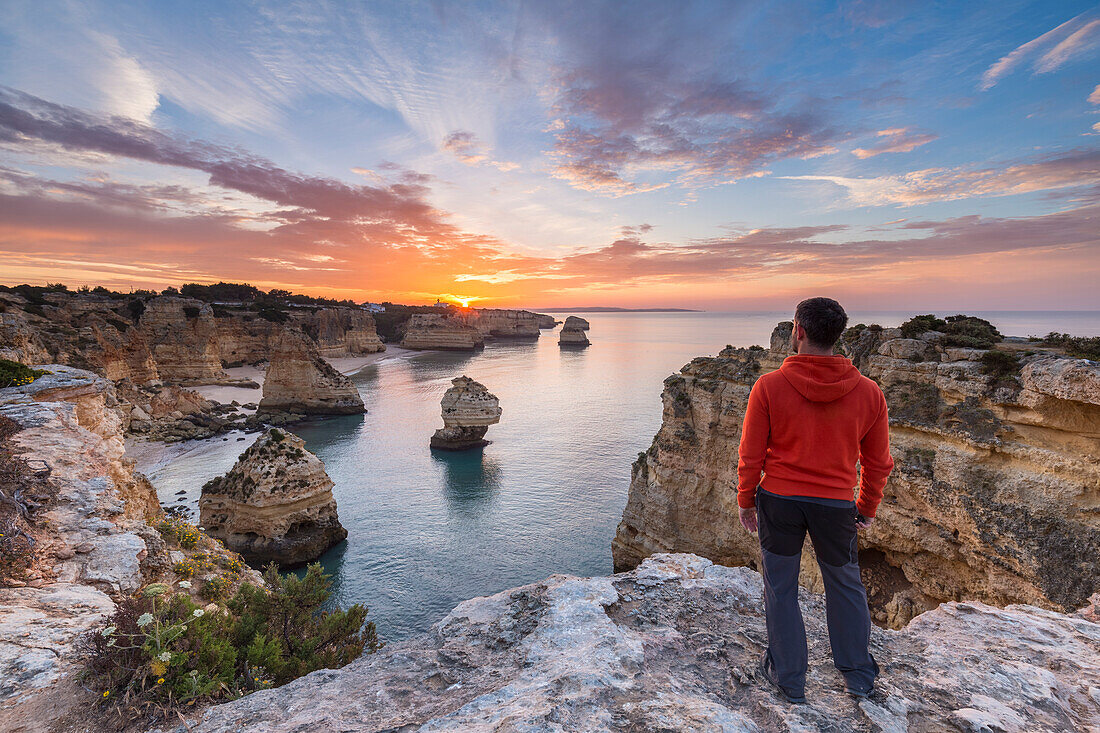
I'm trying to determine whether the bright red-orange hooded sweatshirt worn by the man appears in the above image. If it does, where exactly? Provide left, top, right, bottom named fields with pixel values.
left=737, top=354, right=893, bottom=516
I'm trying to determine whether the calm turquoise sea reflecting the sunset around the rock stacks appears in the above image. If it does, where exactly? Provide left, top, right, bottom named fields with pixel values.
left=144, top=311, right=1100, bottom=639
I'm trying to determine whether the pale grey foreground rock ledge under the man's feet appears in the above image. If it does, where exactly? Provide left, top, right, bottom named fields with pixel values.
left=176, top=555, right=1100, bottom=733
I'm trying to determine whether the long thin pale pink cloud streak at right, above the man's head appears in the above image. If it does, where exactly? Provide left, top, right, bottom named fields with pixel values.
left=784, top=150, right=1100, bottom=206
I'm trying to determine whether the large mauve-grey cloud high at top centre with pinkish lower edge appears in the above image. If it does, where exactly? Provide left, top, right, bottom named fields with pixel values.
left=536, top=3, right=847, bottom=196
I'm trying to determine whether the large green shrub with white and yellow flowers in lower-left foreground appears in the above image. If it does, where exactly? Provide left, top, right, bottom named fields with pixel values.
left=80, top=565, right=382, bottom=716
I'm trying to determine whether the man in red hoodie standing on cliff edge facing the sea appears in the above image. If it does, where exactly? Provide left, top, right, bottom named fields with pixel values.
left=737, top=298, right=893, bottom=702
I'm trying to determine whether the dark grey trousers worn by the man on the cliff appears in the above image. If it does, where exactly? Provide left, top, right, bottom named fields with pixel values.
left=756, top=488, right=878, bottom=696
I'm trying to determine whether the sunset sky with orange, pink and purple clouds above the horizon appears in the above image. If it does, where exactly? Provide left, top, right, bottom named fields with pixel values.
left=0, top=0, right=1100, bottom=310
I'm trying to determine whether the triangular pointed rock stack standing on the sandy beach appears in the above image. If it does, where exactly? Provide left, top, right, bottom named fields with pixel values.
left=260, top=330, right=365, bottom=415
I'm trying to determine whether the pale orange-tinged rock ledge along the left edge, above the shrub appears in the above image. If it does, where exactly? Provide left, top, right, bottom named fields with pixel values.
left=0, top=364, right=163, bottom=702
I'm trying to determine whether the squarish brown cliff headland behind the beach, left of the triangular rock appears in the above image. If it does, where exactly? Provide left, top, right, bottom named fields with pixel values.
left=139, top=296, right=229, bottom=384
